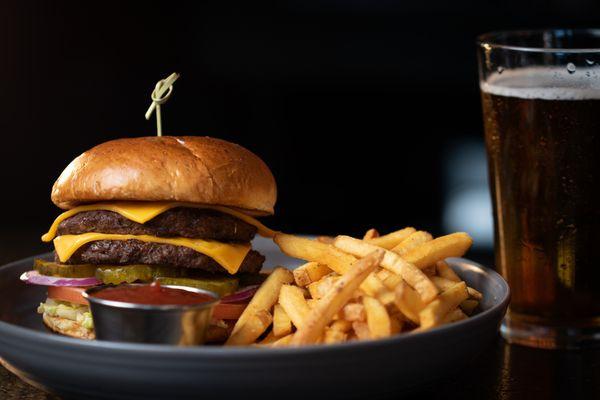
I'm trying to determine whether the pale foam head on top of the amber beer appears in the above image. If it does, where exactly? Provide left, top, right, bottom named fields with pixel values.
left=479, top=67, right=600, bottom=100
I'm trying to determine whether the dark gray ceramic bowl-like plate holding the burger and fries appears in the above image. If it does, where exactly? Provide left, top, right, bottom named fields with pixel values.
left=0, top=241, right=509, bottom=400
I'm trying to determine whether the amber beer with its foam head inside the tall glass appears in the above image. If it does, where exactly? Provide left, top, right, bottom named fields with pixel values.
left=481, top=68, right=600, bottom=338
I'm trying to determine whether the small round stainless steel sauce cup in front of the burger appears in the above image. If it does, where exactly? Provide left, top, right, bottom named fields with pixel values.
left=84, top=284, right=220, bottom=346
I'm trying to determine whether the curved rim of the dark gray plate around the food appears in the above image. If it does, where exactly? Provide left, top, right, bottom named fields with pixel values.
left=0, top=253, right=510, bottom=360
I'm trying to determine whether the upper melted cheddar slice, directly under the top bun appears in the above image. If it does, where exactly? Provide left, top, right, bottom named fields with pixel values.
left=42, top=201, right=275, bottom=242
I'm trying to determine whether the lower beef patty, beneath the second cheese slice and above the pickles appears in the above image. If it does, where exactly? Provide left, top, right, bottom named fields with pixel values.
left=61, top=240, right=265, bottom=273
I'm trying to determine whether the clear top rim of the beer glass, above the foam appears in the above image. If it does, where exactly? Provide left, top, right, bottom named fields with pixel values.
left=476, top=28, right=600, bottom=54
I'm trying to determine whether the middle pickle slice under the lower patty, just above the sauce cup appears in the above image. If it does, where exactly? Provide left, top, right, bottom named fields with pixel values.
left=96, top=264, right=189, bottom=285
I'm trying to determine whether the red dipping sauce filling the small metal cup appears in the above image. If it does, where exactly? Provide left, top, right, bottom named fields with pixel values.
left=91, top=282, right=215, bottom=306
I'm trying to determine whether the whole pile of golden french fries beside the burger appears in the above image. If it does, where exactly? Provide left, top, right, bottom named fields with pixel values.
left=226, top=228, right=482, bottom=347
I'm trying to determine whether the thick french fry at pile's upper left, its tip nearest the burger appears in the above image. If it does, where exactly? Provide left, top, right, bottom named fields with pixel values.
left=273, top=233, right=356, bottom=275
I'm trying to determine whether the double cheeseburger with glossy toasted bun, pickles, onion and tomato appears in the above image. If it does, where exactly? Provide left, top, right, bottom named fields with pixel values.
left=29, top=137, right=277, bottom=339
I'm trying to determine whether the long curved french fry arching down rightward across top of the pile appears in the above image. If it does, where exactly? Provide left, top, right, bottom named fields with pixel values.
left=333, top=236, right=439, bottom=303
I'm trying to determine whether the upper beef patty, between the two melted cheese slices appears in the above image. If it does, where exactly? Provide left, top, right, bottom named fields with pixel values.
left=58, top=207, right=256, bottom=243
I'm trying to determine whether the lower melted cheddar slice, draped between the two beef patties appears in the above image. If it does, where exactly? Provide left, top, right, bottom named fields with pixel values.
left=54, top=232, right=250, bottom=274
